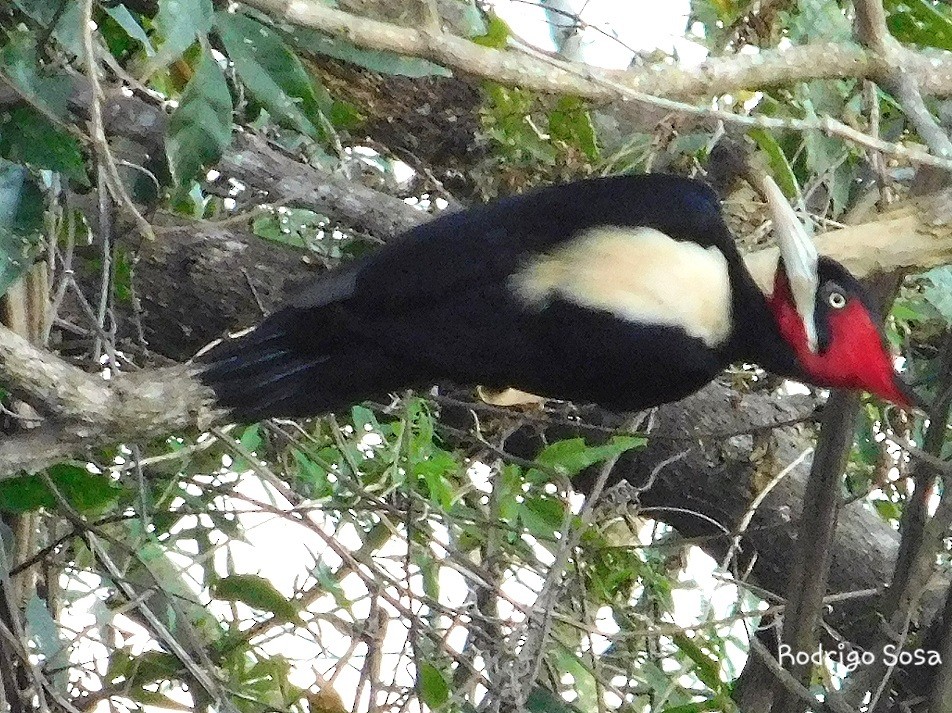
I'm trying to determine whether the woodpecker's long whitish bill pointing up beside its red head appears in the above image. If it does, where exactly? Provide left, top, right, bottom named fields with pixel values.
left=761, top=174, right=820, bottom=353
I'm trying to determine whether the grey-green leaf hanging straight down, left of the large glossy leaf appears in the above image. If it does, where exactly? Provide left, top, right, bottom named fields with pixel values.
left=165, top=54, right=232, bottom=186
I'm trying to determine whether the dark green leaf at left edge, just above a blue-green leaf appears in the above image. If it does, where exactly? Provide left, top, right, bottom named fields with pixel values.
left=0, top=105, right=89, bottom=186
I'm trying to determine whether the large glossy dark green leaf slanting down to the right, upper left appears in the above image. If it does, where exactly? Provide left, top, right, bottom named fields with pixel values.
left=215, top=12, right=332, bottom=138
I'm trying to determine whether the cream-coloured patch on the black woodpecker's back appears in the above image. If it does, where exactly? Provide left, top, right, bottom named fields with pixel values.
left=512, top=226, right=731, bottom=347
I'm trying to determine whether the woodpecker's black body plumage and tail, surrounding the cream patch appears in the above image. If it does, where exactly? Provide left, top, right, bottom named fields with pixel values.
left=204, top=175, right=734, bottom=419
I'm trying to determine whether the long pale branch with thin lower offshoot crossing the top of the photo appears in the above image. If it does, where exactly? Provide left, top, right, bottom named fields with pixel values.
left=240, top=0, right=952, bottom=171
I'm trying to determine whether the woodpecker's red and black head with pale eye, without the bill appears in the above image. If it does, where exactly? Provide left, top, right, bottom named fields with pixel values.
left=769, top=257, right=918, bottom=408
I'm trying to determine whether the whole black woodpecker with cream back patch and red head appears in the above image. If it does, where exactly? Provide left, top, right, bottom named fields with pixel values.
left=199, top=174, right=914, bottom=421
